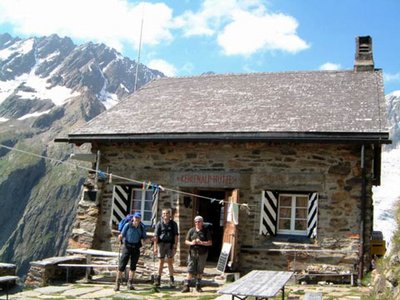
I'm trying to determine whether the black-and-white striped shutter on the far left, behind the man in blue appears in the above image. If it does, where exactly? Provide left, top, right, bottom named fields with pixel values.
left=111, top=185, right=132, bottom=225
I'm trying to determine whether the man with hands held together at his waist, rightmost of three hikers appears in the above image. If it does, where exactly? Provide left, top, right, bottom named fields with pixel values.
left=182, top=216, right=212, bottom=293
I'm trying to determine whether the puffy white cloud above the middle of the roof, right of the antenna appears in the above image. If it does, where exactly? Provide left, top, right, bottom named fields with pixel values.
left=177, top=0, right=309, bottom=56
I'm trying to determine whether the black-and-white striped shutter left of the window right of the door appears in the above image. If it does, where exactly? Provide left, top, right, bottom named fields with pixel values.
left=259, top=191, right=279, bottom=235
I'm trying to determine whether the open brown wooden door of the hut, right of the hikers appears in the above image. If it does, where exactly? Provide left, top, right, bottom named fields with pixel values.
left=223, top=189, right=239, bottom=268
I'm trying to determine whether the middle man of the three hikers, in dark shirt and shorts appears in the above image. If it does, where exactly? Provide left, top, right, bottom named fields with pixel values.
left=154, top=208, right=179, bottom=287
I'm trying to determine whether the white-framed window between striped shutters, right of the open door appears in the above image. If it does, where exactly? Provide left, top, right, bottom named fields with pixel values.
left=277, top=194, right=308, bottom=235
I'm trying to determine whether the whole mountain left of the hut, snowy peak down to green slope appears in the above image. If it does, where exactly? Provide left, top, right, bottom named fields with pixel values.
left=0, top=34, right=164, bottom=275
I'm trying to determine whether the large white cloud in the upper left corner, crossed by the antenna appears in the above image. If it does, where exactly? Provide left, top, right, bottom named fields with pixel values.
left=0, top=0, right=173, bottom=51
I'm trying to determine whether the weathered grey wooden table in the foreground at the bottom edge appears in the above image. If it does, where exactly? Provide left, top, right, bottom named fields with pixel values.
left=218, top=270, right=293, bottom=300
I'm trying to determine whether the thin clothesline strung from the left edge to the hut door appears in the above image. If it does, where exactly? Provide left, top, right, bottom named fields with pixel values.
left=0, top=144, right=252, bottom=213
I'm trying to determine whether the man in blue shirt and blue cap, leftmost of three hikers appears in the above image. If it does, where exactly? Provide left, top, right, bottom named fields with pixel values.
left=114, top=212, right=147, bottom=291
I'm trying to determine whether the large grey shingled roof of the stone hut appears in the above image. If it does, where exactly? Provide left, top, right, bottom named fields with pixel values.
left=68, top=70, right=389, bottom=143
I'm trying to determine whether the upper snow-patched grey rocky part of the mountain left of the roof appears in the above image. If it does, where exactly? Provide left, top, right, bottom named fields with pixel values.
left=0, top=34, right=164, bottom=121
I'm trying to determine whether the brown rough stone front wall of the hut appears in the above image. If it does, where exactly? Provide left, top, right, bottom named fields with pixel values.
left=74, top=142, right=372, bottom=276
